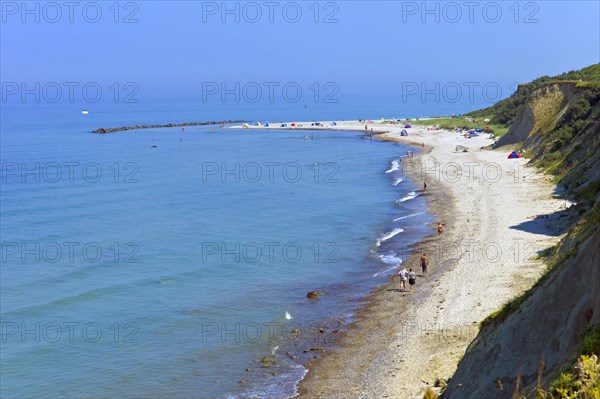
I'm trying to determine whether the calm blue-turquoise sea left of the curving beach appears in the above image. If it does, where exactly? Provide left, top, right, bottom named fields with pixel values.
left=0, top=101, right=430, bottom=398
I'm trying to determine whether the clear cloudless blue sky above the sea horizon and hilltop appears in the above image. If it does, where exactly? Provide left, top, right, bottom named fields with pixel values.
left=0, top=1, right=600, bottom=100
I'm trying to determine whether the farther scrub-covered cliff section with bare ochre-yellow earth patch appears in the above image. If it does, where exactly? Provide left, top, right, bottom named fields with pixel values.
left=496, top=82, right=600, bottom=199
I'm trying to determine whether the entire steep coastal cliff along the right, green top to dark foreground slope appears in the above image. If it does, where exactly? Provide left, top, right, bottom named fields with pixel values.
left=442, top=64, right=600, bottom=399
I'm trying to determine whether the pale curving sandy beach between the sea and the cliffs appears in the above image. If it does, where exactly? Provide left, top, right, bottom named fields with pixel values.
left=231, top=121, right=568, bottom=398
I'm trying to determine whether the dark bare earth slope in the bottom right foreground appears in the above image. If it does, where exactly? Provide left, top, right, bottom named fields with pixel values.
left=443, top=225, right=600, bottom=399
